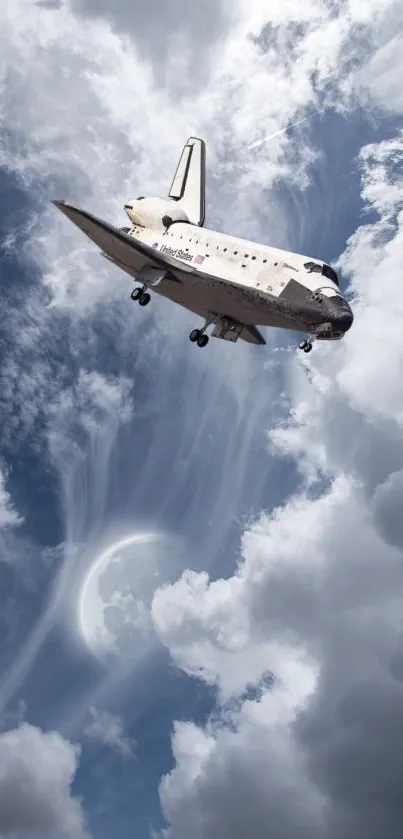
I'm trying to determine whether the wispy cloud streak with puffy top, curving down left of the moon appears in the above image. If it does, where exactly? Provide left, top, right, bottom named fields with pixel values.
left=0, top=370, right=132, bottom=710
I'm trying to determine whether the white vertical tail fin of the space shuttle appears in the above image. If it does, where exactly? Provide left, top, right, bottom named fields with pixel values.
left=169, top=137, right=206, bottom=227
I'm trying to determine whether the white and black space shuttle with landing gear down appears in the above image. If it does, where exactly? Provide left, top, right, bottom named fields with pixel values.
left=53, top=137, right=353, bottom=353
